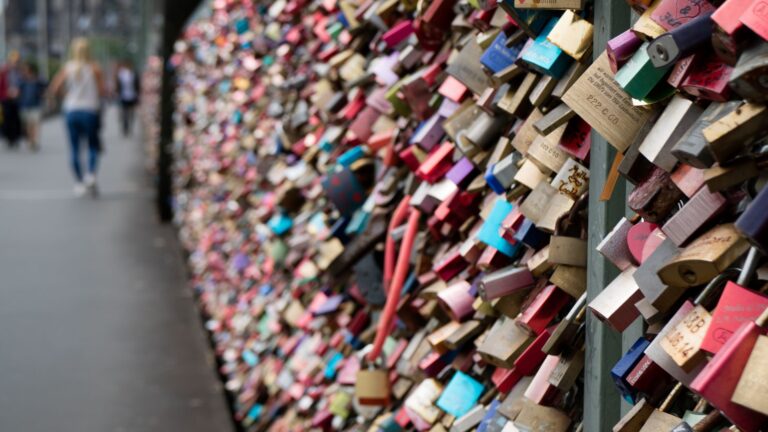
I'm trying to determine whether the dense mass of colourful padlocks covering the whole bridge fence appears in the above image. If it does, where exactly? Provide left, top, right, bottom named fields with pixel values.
left=166, top=0, right=768, bottom=432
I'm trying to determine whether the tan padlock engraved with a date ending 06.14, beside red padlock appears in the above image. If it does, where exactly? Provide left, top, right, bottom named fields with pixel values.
left=661, top=270, right=734, bottom=371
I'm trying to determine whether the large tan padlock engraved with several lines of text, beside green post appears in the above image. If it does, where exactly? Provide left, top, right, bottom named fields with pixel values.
left=563, top=53, right=653, bottom=152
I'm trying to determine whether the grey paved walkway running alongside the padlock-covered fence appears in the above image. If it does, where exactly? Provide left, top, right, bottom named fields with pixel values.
left=0, top=110, right=232, bottom=432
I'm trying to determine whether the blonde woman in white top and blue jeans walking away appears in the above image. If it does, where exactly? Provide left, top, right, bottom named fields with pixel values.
left=50, top=38, right=106, bottom=196
